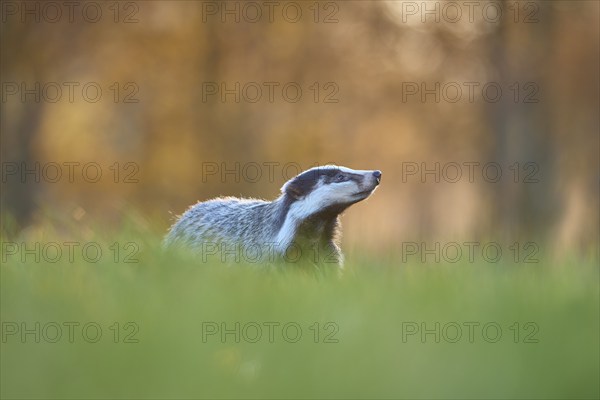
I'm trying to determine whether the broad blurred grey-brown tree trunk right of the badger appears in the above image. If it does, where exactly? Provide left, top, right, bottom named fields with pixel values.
left=487, top=3, right=556, bottom=240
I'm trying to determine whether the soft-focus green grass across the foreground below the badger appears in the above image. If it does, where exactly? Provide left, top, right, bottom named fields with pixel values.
left=0, top=230, right=600, bottom=398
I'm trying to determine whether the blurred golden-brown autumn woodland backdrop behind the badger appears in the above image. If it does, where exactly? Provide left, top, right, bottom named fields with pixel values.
left=1, top=1, right=600, bottom=253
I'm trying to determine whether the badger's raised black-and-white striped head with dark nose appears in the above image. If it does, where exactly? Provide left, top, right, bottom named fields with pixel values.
left=281, top=165, right=381, bottom=216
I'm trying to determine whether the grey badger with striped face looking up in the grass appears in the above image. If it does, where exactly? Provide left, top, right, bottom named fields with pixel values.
left=164, top=165, right=381, bottom=267
